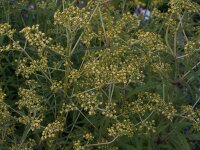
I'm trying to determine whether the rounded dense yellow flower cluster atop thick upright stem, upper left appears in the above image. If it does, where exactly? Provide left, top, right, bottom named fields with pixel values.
left=54, top=6, right=90, bottom=31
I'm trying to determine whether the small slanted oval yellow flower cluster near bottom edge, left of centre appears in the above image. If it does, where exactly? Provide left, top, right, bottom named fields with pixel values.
left=41, top=120, right=63, bottom=140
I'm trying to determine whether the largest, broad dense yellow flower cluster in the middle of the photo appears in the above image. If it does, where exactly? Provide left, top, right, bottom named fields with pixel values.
left=82, top=48, right=144, bottom=87
